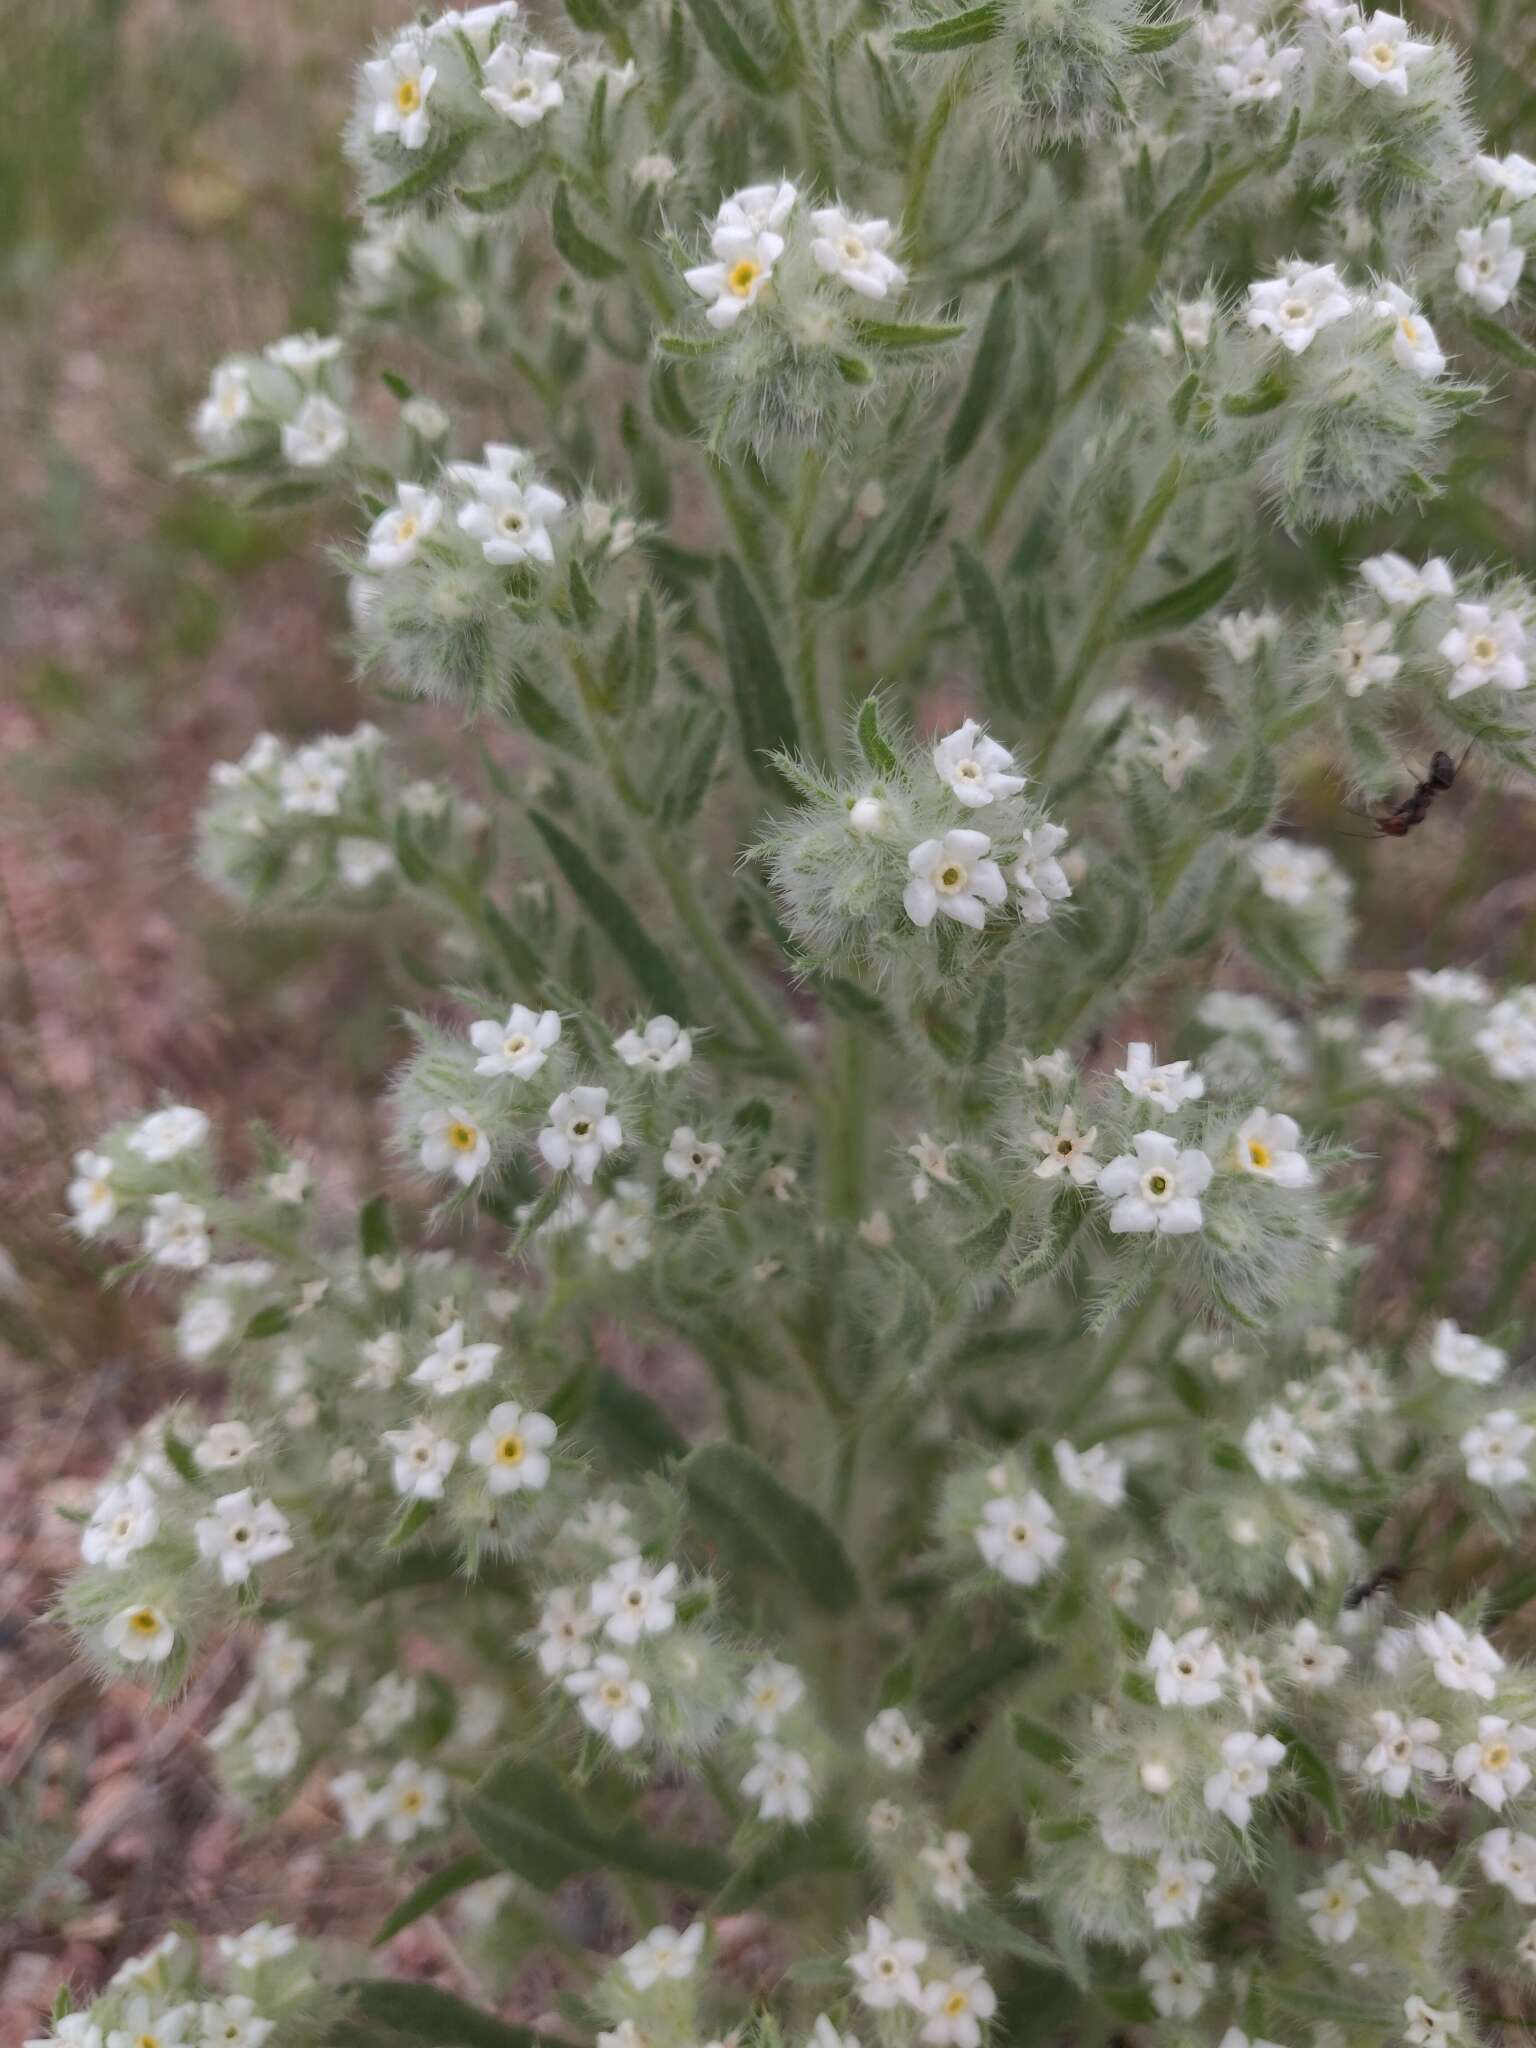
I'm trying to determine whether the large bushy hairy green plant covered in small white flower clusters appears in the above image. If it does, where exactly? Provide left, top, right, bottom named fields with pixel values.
left=39, top=0, right=1536, bottom=2048
